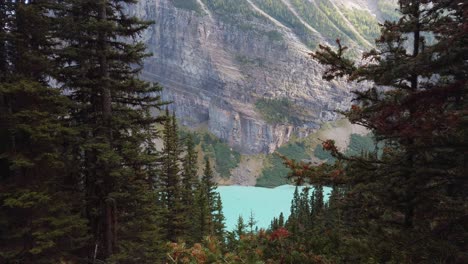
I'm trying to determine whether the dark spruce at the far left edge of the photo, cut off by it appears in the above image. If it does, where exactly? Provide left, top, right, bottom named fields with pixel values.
left=0, top=0, right=87, bottom=263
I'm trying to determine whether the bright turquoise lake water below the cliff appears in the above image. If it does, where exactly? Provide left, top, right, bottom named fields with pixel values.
left=218, top=185, right=330, bottom=231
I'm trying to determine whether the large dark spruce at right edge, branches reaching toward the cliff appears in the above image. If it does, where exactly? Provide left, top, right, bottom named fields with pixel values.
left=287, top=0, right=468, bottom=263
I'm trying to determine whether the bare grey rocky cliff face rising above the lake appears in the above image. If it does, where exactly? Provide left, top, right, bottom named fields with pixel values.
left=125, top=0, right=392, bottom=154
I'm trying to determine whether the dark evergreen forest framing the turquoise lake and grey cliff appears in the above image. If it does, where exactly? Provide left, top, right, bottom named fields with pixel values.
left=0, top=0, right=468, bottom=264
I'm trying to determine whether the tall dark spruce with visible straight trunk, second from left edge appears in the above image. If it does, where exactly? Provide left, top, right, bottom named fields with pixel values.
left=49, top=0, right=165, bottom=263
